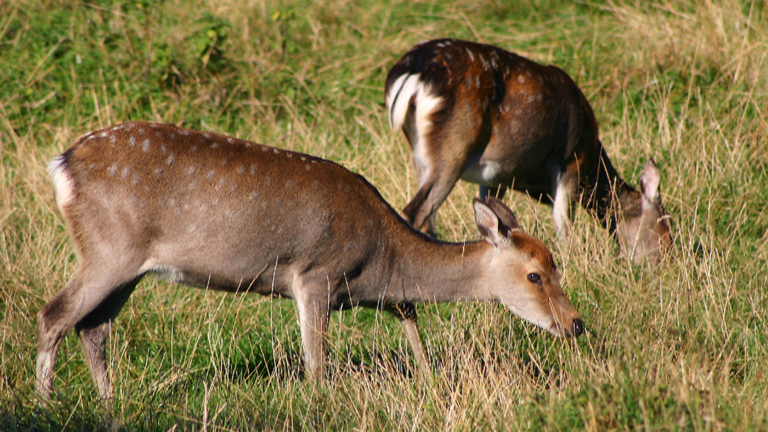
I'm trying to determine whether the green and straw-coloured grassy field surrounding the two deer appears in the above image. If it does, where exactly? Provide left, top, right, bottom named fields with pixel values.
left=0, top=0, right=768, bottom=431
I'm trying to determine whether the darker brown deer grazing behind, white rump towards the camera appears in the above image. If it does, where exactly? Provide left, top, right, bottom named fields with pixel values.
left=385, top=39, right=672, bottom=262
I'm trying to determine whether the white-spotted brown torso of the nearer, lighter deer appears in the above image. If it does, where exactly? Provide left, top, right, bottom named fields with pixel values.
left=51, top=123, right=397, bottom=294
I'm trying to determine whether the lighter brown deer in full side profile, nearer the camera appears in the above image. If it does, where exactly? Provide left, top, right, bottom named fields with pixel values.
left=37, top=123, right=584, bottom=400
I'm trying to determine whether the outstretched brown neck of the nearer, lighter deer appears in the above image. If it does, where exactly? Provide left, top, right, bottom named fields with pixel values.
left=389, top=231, right=493, bottom=303
